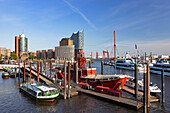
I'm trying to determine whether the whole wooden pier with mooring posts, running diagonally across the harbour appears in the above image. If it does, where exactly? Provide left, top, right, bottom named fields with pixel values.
left=0, top=61, right=165, bottom=110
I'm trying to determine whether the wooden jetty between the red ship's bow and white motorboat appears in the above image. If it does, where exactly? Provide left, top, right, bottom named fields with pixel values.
left=123, top=86, right=159, bottom=102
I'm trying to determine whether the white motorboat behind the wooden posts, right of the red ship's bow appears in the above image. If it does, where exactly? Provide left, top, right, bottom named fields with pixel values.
left=125, top=76, right=161, bottom=94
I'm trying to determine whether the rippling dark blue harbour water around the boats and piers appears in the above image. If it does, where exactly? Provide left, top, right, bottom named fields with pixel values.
left=0, top=60, right=170, bottom=113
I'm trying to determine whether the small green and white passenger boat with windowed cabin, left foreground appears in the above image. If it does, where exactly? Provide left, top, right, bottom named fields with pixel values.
left=20, top=82, right=59, bottom=102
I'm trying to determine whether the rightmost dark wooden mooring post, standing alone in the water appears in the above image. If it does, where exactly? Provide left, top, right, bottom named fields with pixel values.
left=161, top=69, right=165, bottom=106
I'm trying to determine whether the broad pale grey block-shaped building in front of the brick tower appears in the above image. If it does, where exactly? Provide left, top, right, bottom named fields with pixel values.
left=55, top=45, right=74, bottom=61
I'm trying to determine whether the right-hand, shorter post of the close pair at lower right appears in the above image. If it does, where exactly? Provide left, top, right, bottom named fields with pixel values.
left=146, top=64, right=150, bottom=107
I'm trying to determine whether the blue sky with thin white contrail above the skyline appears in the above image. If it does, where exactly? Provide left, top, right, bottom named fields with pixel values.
left=0, top=0, right=170, bottom=57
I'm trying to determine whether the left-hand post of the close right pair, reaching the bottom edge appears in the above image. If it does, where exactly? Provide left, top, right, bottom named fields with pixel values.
left=143, top=65, right=147, bottom=113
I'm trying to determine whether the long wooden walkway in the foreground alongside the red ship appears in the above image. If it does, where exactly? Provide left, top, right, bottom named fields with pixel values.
left=76, top=87, right=143, bottom=110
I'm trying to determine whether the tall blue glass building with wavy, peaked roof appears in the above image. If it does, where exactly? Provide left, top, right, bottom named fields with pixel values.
left=71, top=30, right=84, bottom=50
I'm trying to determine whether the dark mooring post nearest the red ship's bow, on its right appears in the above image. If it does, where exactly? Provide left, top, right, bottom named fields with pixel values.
left=135, top=63, right=138, bottom=99
